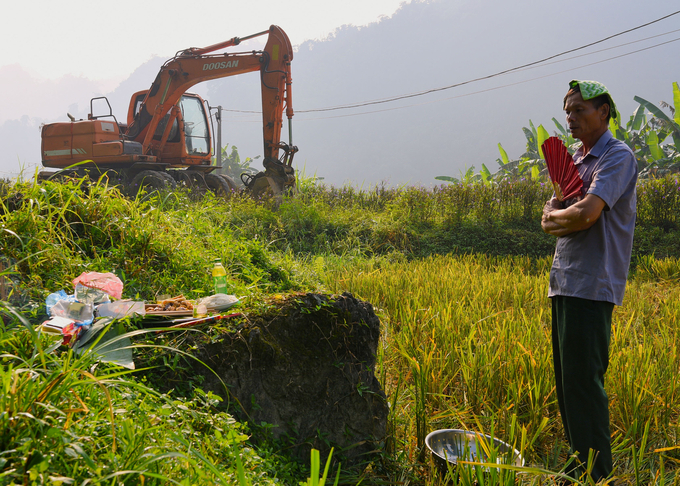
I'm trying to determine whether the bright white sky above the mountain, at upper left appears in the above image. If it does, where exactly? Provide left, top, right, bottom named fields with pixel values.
left=0, top=0, right=408, bottom=84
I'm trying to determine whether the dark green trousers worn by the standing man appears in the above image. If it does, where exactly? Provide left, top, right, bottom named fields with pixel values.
left=552, top=296, right=614, bottom=481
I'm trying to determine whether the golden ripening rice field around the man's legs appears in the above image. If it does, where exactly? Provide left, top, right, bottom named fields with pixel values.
left=325, top=255, right=680, bottom=485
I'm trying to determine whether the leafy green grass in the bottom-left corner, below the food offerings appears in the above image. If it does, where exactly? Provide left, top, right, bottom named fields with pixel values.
left=0, top=307, right=298, bottom=485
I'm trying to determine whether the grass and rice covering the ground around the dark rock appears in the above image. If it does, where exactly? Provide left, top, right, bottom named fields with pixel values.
left=0, top=170, right=680, bottom=484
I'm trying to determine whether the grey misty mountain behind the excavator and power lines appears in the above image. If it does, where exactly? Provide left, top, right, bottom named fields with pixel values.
left=0, top=0, right=680, bottom=186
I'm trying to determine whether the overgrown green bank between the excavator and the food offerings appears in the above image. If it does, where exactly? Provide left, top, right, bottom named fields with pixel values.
left=1, top=175, right=308, bottom=306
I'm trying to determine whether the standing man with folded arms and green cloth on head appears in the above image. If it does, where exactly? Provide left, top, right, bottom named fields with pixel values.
left=541, top=81, right=637, bottom=481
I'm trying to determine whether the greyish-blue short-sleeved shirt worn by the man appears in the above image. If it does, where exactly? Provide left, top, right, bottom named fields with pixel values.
left=548, top=130, right=638, bottom=305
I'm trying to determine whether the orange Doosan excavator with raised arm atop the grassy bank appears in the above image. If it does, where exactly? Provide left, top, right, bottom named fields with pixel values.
left=38, top=25, right=298, bottom=197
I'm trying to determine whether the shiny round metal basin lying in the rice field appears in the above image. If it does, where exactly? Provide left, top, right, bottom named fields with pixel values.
left=425, top=429, right=524, bottom=469
